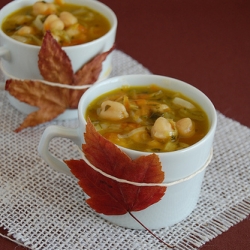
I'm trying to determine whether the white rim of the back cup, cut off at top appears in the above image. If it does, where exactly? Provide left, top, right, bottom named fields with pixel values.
left=0, top=0, right=118, bottom=50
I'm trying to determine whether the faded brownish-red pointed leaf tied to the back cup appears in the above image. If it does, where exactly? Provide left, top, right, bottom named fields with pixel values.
left=5, top=31, right=113, bottom=132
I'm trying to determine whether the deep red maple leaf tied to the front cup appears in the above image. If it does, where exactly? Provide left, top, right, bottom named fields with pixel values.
left=65, top=118, right=166, bottom=215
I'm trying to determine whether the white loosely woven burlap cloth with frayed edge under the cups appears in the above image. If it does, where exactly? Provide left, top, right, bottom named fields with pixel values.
left=0, top=50, right=250, bottom=250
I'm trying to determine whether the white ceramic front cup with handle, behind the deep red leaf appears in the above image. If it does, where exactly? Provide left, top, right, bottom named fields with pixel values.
left=38, top=75, right=217, bottom=229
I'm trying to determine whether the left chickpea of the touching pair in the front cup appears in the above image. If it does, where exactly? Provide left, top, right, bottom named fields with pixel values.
left=151, top=117, right=177, bottom=142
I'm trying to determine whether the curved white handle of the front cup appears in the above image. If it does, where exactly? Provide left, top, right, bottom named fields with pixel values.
left=38, top=125, right=82, bottom=176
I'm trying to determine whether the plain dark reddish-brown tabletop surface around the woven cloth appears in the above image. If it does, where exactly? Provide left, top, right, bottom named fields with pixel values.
left=0, top=0, right=250, bottom=250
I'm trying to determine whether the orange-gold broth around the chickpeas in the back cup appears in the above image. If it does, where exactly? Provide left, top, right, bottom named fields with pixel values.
left=2, top=2, right=110, bottom=46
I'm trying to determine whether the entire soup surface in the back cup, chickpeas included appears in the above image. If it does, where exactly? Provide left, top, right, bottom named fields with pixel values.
left=2, top=0, right=110, bottom=46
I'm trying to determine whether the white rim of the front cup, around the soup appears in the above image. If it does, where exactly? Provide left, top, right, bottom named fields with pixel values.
left=78, top=74, right=217, bottom=155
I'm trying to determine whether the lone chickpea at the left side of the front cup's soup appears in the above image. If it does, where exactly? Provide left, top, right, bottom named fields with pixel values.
left=99, top=100, right=129, bottom=121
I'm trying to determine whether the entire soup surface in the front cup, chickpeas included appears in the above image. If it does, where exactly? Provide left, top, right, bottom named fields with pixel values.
left=85, top=85, right=209, bottom=152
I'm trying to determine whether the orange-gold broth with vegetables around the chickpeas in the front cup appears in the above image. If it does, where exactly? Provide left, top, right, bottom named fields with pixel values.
left=85, top=84, right=209, bottom=152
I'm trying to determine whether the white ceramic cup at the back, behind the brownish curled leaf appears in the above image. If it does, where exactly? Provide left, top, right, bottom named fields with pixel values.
left=0, top=0, right=117, bottom=119
